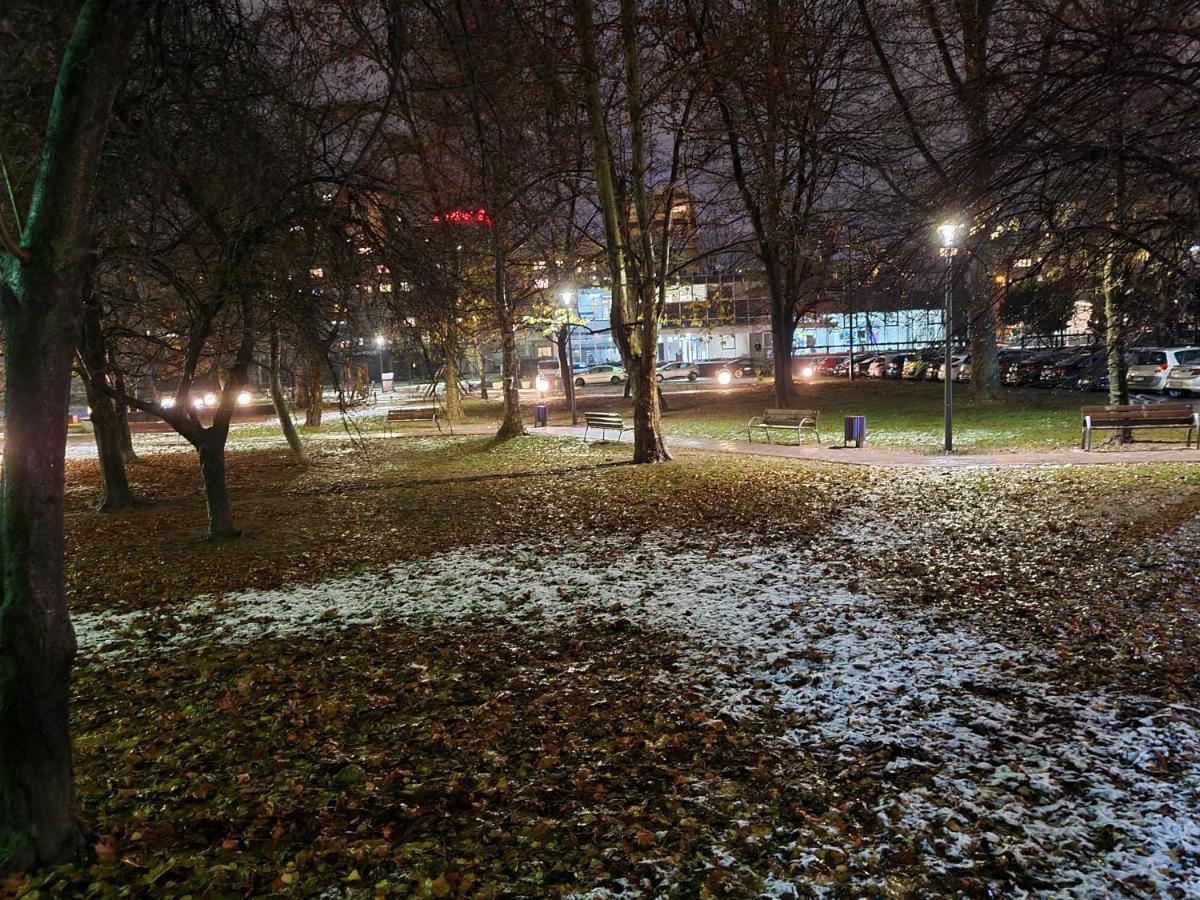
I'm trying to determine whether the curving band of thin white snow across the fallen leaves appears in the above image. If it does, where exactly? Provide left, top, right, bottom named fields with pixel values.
left=76, top=544, right=1200, bottom=898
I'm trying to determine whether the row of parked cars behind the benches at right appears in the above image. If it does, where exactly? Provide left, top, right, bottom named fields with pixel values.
left=802, top=346, right=1200, bottom=397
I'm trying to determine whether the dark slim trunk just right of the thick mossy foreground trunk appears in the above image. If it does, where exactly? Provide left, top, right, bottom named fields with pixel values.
left=79, top=300, right=134, bottom=512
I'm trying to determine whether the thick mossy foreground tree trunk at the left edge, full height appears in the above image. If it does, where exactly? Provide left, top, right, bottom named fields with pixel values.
left=0, top=0, right=145, bottom=875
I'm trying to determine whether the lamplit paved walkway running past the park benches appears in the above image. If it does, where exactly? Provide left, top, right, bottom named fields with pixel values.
left=529, top=425, right=1200, bottom=468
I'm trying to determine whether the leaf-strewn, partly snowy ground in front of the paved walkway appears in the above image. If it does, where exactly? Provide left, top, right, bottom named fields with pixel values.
left=13, top=438, right=1200, bottom=896
